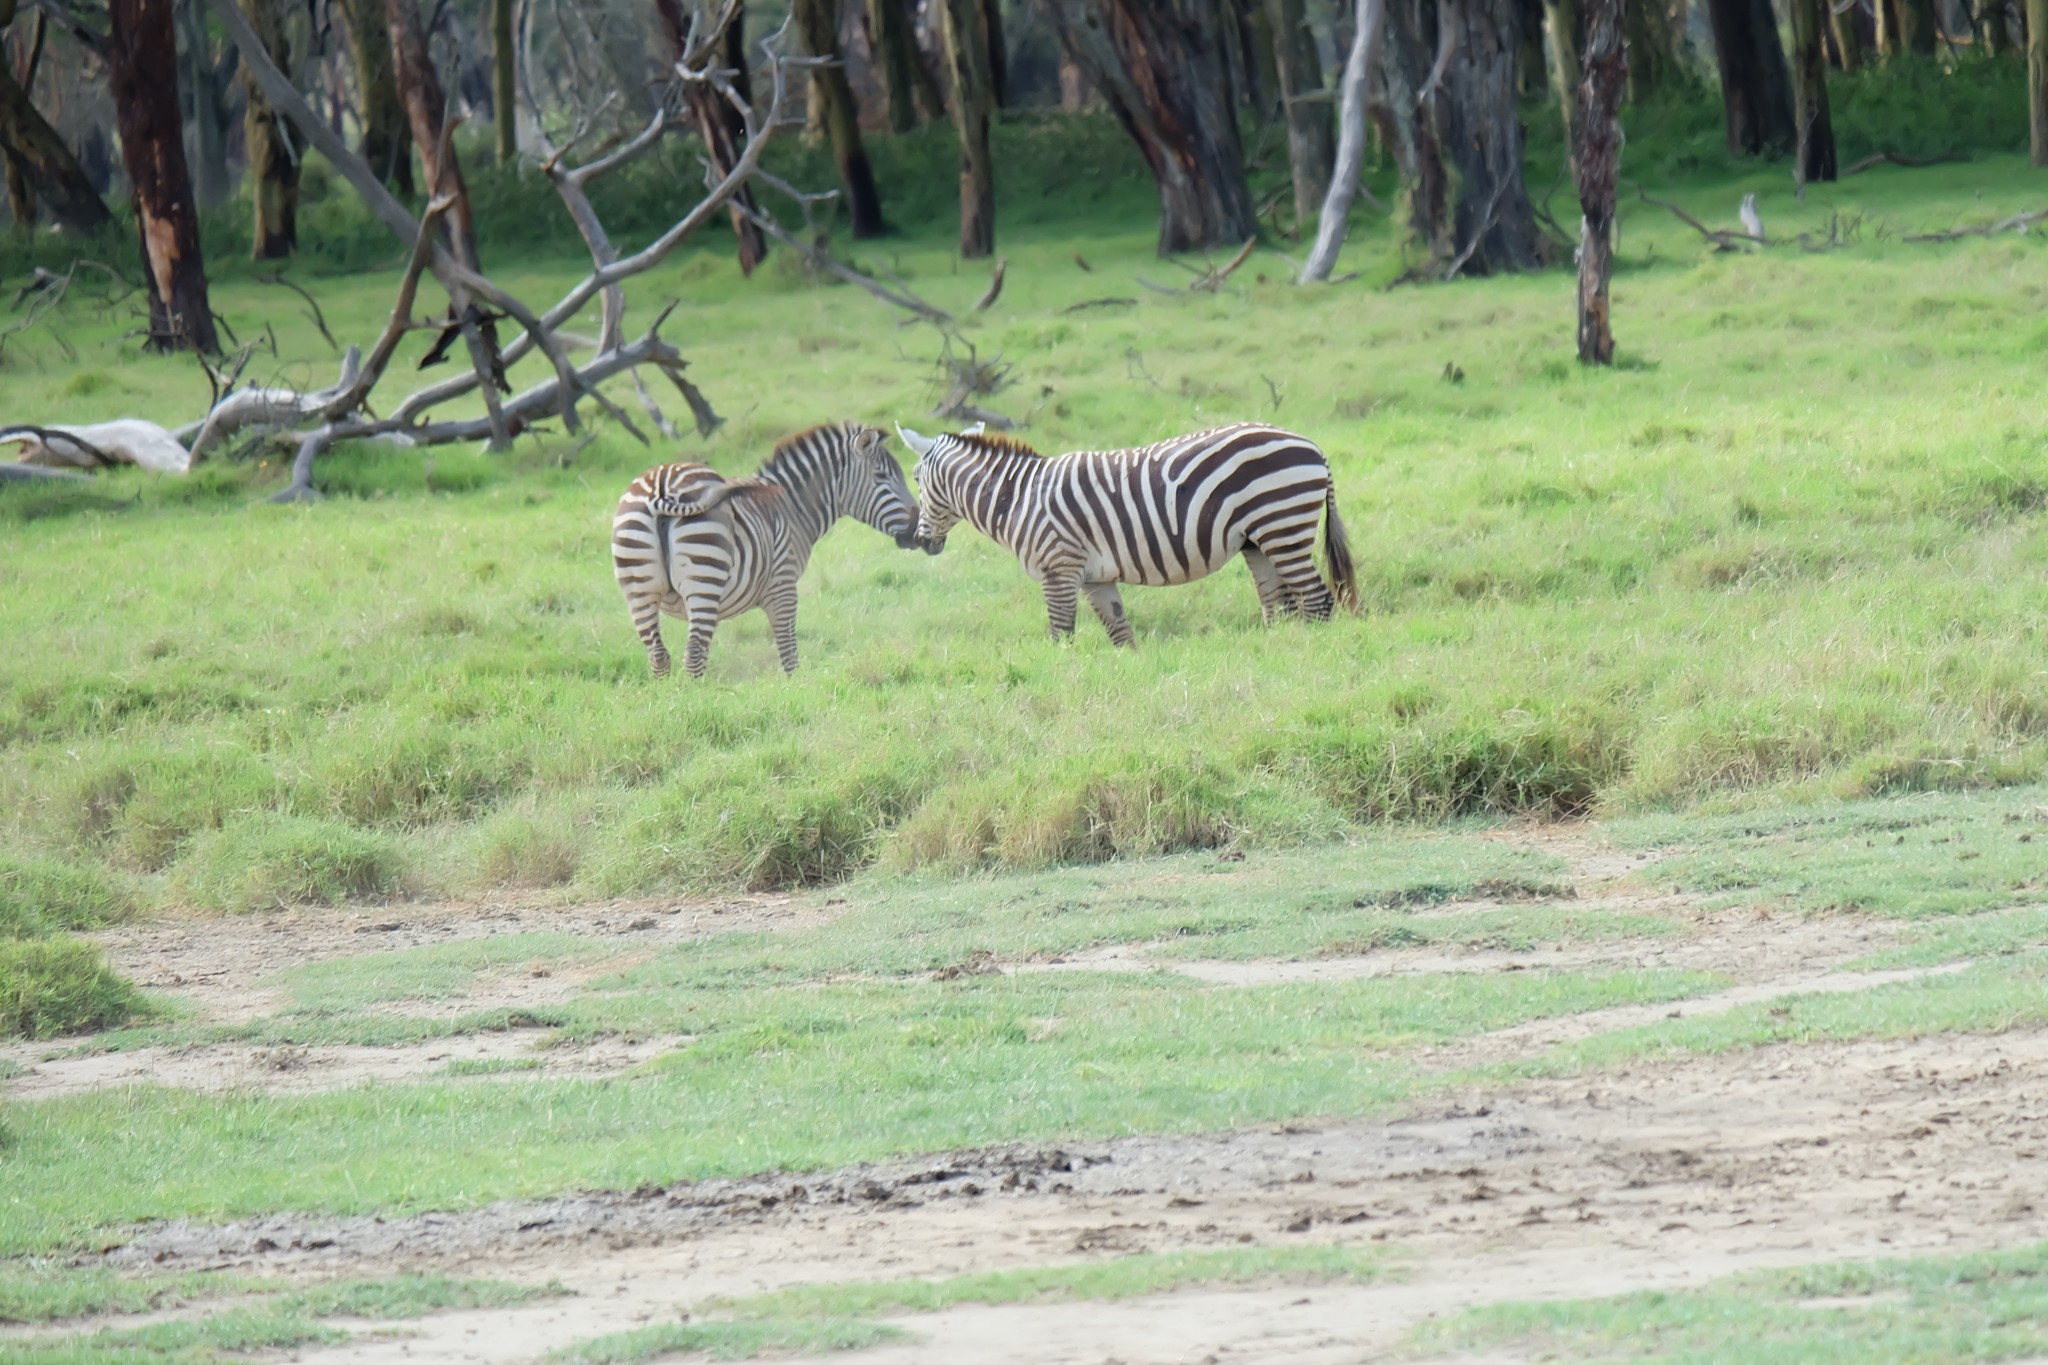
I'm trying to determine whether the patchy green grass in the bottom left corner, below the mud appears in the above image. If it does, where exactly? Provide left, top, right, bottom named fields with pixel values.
left=0, top=1271, right=563, bottom=1365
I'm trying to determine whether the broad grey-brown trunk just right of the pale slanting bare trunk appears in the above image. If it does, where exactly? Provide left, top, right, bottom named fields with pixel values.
left=1380, top=0, right=1548, bottom=278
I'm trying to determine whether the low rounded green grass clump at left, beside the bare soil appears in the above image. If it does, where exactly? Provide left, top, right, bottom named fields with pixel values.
left=172, top=814, right=403, bottom=913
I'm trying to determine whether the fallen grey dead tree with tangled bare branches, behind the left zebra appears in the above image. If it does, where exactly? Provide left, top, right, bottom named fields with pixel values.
left=211, top=0, right=815, bottom=501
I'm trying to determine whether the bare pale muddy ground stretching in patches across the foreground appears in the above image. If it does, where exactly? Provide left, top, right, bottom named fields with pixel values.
left=4, top=839, right=2048, bottom=1365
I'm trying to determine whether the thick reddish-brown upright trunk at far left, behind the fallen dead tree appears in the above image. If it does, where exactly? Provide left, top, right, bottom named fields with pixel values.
left=106, top=0, right=221, bottom=354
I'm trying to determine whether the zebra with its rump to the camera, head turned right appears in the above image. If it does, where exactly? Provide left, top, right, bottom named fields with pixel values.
left=612, top=422, right=920, bottom=677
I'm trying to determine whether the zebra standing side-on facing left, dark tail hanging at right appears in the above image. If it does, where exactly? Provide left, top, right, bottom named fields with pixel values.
left=897, top=422, right=1358, bottom=645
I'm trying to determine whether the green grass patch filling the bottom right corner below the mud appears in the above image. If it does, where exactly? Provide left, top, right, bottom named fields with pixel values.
left=1417, top=1246, right=2048, bottom=1365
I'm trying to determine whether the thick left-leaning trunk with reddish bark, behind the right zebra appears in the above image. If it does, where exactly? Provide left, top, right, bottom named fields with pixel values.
left=1040, top=0, right=1257, bottom=256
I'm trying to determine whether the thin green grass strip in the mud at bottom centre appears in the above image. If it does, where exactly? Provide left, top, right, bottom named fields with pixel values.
left=547, top=1246, right=1389, bottom=1365
